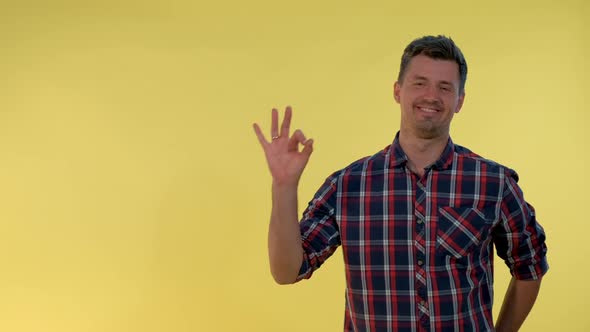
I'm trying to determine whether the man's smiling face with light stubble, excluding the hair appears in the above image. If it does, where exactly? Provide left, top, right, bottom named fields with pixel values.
left=394, top=55, right=465, bottom=139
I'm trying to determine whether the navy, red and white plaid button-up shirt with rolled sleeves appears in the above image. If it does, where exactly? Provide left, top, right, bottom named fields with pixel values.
left=297, top=134, right=548, bottom=331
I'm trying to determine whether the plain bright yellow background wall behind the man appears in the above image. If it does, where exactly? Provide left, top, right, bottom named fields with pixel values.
left=0, top=0, right=590, bottom=332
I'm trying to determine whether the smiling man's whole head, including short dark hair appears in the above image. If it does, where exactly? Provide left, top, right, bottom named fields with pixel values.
left=394, top=36, right=467, bottom=139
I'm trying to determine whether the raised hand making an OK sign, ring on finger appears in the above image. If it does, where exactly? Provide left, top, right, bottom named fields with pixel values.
left=254, top=106, right=313, bottom=186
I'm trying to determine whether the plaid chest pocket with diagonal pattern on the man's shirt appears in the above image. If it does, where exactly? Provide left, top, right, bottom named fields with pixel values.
left=436, top=206, right=494, bottom=259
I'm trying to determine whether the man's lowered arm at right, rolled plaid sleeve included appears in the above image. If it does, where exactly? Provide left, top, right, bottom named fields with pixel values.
left=493, top=171, right=549, bottom=332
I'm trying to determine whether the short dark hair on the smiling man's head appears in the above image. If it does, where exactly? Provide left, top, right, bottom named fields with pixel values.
left=397, top=35, right=467, bottom=93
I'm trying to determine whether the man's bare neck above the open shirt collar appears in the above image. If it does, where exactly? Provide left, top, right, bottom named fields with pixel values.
left=399, top=131, right=449, bottom=176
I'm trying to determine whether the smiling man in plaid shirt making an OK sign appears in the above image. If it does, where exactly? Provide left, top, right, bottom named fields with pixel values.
left=254, top=36, right=548, bottom=331
